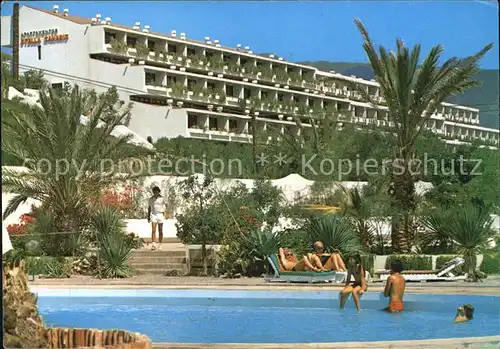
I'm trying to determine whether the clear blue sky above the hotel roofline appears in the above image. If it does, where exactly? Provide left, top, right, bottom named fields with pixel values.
left=2, top=0, right=499, bottom=69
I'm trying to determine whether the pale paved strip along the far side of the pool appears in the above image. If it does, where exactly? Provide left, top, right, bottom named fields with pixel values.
left=29, top=275, right=500, bottom=295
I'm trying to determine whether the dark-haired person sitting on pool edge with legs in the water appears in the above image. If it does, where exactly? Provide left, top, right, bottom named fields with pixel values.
left=340, top=254, right=368, bottom=312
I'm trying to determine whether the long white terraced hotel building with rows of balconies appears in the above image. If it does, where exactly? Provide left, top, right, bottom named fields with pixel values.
left=1, top=6, right=499, bottom=146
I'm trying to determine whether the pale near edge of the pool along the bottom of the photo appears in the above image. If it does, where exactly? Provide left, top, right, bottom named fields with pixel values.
left=153, top=335, right=500, bottom=349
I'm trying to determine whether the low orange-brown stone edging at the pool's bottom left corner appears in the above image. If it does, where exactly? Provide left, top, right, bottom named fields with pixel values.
left=46, top=328, right=152, bottom=349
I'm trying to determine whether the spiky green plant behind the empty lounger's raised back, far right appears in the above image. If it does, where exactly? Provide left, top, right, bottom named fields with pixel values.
left=423, top=206, right=495, bottom=275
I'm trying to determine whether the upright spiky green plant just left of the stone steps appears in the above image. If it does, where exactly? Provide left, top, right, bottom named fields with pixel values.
left=91, top=206, right=133, bottom=278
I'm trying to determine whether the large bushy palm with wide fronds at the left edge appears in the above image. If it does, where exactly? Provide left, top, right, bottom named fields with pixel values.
left=2, top=87, right=150, bottom=247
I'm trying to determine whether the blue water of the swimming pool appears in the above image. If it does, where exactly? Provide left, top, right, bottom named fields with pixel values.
left=33, top=289, right=500, bottom=343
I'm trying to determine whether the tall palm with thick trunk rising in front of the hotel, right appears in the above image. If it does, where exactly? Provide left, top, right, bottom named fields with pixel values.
left=355, top=19, right=493, bottom=252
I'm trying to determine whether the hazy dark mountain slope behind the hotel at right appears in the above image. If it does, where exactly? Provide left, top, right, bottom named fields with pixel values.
left=300, top=61, right=500, bottom=129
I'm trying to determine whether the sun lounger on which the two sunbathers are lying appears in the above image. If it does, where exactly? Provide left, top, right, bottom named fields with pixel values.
left=265, top=255, right=347, bottom=283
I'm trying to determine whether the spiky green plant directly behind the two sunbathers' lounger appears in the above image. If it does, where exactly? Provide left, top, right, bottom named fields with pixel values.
left=303, top=214, right=362, bottom=253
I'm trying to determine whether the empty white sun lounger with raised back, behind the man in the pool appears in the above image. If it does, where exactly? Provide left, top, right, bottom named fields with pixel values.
left=375, top=257, right=465, bottom=282
